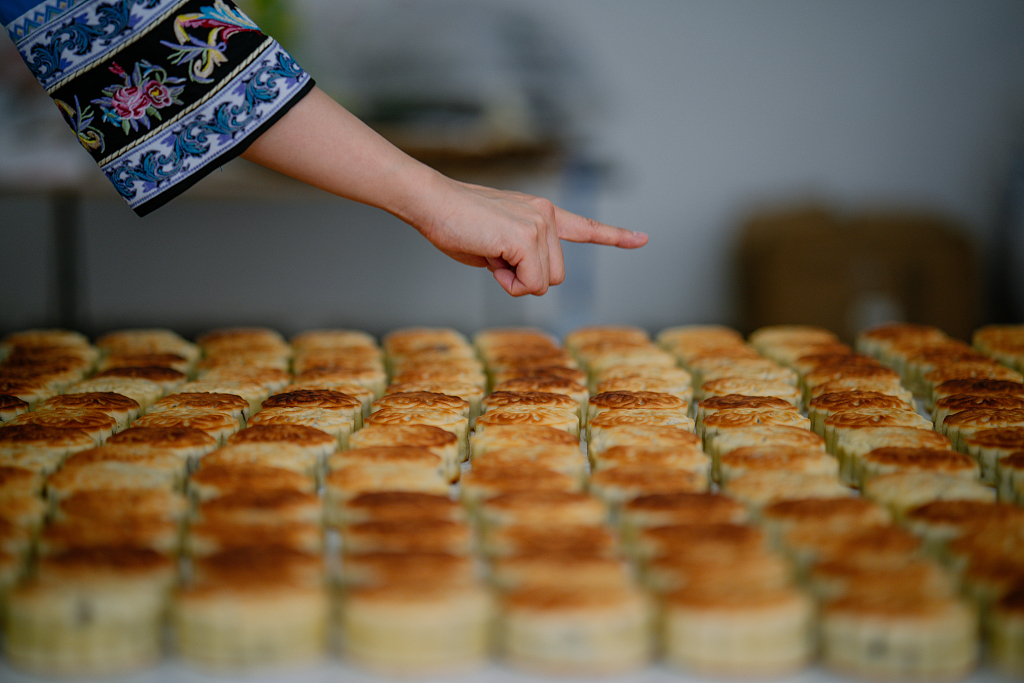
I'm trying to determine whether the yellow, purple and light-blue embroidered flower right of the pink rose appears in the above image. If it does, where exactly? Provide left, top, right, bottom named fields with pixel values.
left=161, top=0, right=259, bottom=83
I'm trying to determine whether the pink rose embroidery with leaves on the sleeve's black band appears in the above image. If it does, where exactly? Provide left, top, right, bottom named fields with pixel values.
left=92, top=60, right=184, bottom=134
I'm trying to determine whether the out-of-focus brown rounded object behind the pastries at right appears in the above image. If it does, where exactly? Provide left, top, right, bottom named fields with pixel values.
left=735, top=205, right=981, bottom=341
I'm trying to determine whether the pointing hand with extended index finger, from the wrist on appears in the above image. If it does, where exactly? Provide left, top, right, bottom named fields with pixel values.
left=418, top=176, right=647, bottom=297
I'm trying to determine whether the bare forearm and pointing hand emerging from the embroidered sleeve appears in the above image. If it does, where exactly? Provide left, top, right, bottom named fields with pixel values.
left=242, top=88, right=647, bottom=296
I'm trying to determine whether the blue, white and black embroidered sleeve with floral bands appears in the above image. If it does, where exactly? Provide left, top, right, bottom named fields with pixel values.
left=0, top=0, right=313, bottom=216
